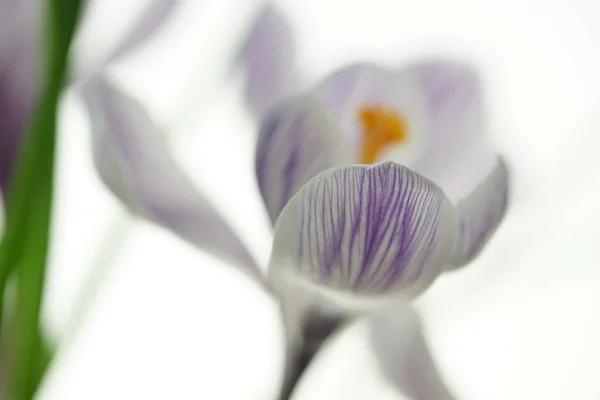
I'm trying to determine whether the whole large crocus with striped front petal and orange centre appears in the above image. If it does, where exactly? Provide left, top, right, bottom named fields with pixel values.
left=84, top=3, right=508, bottom=400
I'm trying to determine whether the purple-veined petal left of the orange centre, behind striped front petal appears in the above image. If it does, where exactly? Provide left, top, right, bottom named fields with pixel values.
left=256, top=96, right=352, bottom=224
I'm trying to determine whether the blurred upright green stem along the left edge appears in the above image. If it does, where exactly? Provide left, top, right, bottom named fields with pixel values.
left=0, top=0, right=80, bottom=400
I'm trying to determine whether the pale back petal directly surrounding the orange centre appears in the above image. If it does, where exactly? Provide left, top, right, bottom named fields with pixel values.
left=316, top=64, right=429, bottom=166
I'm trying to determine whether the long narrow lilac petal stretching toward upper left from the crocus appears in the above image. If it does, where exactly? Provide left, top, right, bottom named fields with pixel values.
left=84, top=77, right=264, bottom=288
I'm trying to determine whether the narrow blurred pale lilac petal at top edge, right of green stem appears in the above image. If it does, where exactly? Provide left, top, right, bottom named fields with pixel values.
left=106, top=0, right=179, bottom=64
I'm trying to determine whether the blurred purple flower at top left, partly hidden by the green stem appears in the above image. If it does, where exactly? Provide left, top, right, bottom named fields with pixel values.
left=0, top=0, right=177, bottom=191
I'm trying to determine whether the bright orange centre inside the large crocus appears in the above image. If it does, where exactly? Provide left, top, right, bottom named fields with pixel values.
left=359, top=106, right=408, bottom=164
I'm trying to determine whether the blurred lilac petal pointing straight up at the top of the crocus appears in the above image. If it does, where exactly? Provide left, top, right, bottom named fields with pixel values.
left=240, top=3, right=295, bottom=118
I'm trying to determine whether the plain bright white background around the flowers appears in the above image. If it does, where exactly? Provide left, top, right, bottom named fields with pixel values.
left=34, top=0, right=600, bottom=400
